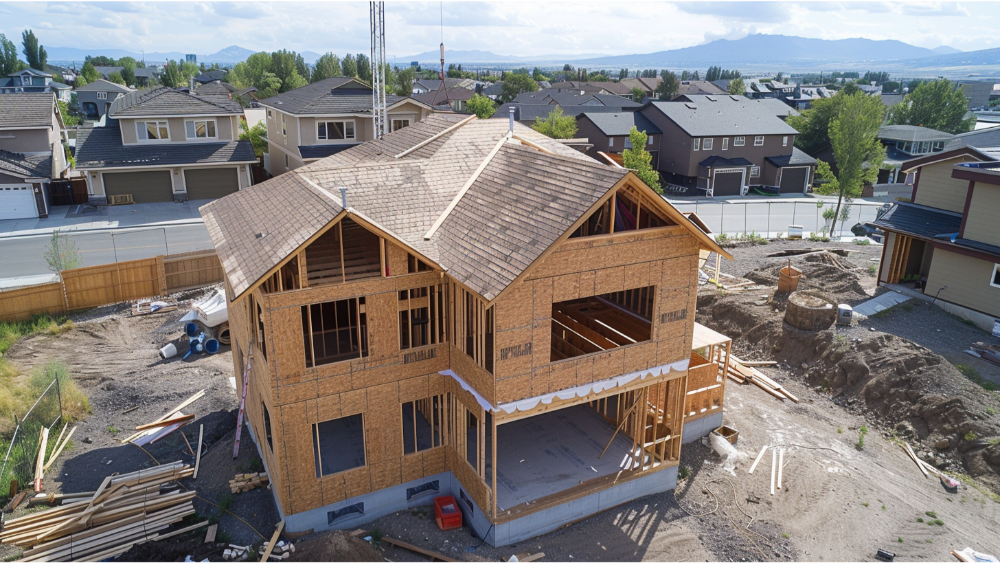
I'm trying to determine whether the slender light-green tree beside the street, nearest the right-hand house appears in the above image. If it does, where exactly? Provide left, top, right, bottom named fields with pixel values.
left=816, top=93, right=885, bottom=236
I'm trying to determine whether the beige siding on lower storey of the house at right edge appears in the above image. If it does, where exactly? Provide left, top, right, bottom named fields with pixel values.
left=924, top=248, right=1000, bottom=316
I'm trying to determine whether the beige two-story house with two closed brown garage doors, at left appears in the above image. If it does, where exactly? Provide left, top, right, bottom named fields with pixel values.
left=76, top=88, right=257, bottom=203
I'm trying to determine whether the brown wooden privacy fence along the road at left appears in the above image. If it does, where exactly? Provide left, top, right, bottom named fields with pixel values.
left=0, top=250, right=223, bottom=321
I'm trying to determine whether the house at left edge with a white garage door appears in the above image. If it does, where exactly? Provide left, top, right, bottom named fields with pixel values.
left=0, top=92, right=69, bottom=219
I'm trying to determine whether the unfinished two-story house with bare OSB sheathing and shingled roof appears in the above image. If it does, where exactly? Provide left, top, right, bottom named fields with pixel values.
left=202, top=113, right=729, bottom=545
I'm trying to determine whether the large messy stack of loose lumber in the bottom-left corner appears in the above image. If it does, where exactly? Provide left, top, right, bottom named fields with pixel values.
left=0, top=462, right=195, bottom=563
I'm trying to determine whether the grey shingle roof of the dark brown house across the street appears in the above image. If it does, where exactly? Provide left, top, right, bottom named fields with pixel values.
left=649, top=96, right=798, bottom=137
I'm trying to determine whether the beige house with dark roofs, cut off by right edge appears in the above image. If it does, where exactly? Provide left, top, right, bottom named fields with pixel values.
left=871, top=147, right=1000, bottom=330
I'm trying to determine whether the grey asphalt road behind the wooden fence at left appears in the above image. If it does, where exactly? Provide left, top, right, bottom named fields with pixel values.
left=0, top=223, right=212, bottom=278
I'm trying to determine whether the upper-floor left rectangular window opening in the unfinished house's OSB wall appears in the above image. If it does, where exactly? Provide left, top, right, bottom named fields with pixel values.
left=302, top=297, right=368, bottom=368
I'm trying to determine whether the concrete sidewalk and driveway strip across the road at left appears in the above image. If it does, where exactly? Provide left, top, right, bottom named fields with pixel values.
left=0, top=199, right=212, bottom=239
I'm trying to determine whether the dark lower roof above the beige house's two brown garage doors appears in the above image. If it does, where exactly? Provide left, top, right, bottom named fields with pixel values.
left=76, top=127, right=257, bottom=170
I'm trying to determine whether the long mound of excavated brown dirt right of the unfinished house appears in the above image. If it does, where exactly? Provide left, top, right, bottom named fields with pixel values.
left=698, top=290, right=1000, bottom=491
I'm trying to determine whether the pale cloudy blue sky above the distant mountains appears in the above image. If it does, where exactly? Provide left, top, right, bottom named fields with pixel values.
left=0, top=0, right=1000, bottom=57
